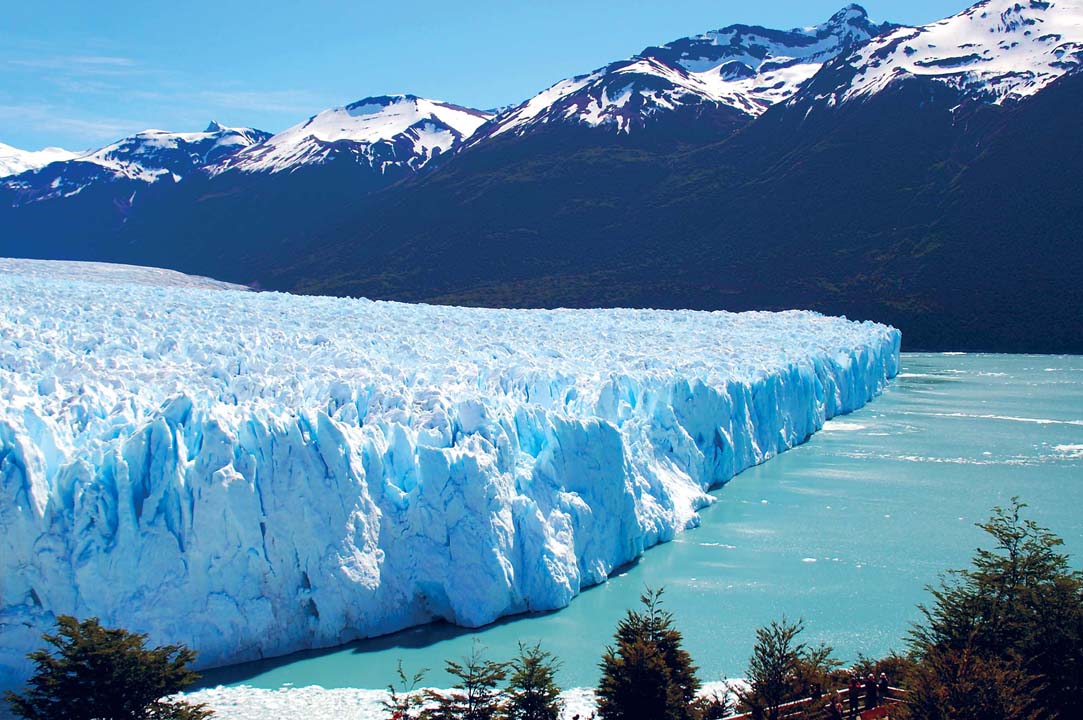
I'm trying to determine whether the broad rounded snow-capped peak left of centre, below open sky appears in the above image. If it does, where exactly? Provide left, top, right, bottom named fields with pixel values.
left=208, top=95, right=491, bottom=174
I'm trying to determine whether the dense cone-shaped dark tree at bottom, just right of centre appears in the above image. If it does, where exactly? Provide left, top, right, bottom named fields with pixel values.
left=597, top=589, right=700, bottom=720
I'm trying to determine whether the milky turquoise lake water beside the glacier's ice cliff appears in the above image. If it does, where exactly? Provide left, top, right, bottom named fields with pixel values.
left=197, top=354, right=1083, bottom=689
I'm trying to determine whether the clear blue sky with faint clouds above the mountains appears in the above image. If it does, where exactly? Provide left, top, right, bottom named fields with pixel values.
left=0, top=0, right=970, bottom=149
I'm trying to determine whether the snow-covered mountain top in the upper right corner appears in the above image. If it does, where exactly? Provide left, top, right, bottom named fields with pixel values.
left=819, top=0, right=1083, bottom=104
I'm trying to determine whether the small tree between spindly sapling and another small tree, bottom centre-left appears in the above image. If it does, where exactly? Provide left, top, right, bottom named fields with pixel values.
left=420, top=643, right=508, bottom=720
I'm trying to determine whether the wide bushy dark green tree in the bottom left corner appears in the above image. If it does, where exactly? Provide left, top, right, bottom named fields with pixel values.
left=6, top=615, right=211, bottom=720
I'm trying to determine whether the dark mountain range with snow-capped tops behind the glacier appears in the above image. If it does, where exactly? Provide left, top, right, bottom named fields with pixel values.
left=0, top=0, right=1083, bottom=352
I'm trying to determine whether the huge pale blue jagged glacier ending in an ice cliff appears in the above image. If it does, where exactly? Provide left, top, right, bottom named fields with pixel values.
left=0, top=258, right=900, bottom=684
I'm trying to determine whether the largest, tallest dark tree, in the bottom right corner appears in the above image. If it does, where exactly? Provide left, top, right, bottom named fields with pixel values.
left=911, top=498, right=1083, bottom=719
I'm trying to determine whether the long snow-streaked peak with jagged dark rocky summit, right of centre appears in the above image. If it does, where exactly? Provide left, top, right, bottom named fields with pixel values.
left=471, top=4, right=893, bottom=144
